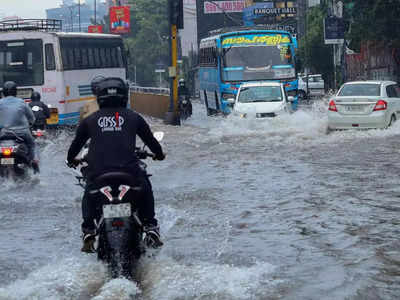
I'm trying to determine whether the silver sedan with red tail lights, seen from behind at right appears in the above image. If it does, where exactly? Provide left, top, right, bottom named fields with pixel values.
left=328, top=81, right=400, bottom=130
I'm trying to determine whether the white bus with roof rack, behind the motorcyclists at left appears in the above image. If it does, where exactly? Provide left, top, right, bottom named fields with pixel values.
left=0, top=20, right=126, bottom=125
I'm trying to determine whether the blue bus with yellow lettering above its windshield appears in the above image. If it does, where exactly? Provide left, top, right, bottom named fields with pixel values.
left=198, top=28, right=298, bottom=115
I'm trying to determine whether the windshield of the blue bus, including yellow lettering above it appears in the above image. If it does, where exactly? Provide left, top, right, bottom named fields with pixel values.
left=222, top=34, right=295, bottom=81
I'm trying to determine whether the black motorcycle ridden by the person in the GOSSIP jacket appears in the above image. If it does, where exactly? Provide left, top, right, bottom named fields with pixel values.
left=69, top=132, right=164, bottom=278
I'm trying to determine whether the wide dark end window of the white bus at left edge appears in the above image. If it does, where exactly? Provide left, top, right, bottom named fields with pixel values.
left=0, top=39, right=44, bottom=86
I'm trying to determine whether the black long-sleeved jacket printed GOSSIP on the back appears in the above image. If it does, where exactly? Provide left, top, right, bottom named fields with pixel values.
left=67, top=108, right=163, bottom=178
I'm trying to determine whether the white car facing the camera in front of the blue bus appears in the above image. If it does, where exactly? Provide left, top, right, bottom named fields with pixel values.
left=228, top=82, right=294, bottom=118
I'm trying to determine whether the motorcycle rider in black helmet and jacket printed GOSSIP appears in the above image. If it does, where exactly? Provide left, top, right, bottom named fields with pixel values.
left=67, top=77, right=165, bottom=252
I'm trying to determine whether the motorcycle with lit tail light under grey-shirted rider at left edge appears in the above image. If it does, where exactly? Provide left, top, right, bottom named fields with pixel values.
left=0, top=131, right=32, bottom=177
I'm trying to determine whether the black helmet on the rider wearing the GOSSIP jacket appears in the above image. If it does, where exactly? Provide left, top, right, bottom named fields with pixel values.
left=96, top=77, right=129, bottom=108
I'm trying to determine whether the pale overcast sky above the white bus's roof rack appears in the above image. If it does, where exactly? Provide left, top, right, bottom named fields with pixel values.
left=0, top=0, right=63, bottom=19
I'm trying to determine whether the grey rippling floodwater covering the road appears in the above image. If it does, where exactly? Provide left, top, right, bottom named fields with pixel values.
left=0, top=102, right=400, bottom=300
